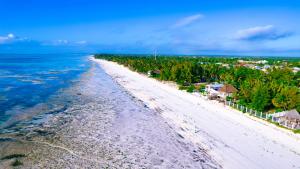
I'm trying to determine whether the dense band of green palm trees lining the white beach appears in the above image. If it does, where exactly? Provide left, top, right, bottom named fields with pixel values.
left=95, top=54, right=300, bottom=112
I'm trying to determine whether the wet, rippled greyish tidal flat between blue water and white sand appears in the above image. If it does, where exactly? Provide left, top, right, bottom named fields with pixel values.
left=0, top=60, right=221, bottom=169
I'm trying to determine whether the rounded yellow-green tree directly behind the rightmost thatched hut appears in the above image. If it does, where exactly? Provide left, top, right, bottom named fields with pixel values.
left=272, top=87, right=300, bottom=110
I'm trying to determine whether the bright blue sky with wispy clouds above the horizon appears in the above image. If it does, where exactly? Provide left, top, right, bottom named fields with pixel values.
left=0, top=0, right=300, bottom=57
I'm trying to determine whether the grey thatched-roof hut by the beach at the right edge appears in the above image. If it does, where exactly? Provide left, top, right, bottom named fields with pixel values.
left=272, top=109, right=300, bottom=129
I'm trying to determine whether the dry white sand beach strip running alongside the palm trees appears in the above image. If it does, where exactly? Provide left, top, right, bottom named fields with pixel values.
left=93, top=59, right=300, bottom=169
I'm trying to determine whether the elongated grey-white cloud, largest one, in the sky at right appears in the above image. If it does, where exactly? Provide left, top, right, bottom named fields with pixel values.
left=235, top=25, right=292, bottom=41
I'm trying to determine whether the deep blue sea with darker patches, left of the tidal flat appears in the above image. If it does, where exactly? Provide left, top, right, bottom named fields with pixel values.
left=0, top=54, right=89, bottom=126
